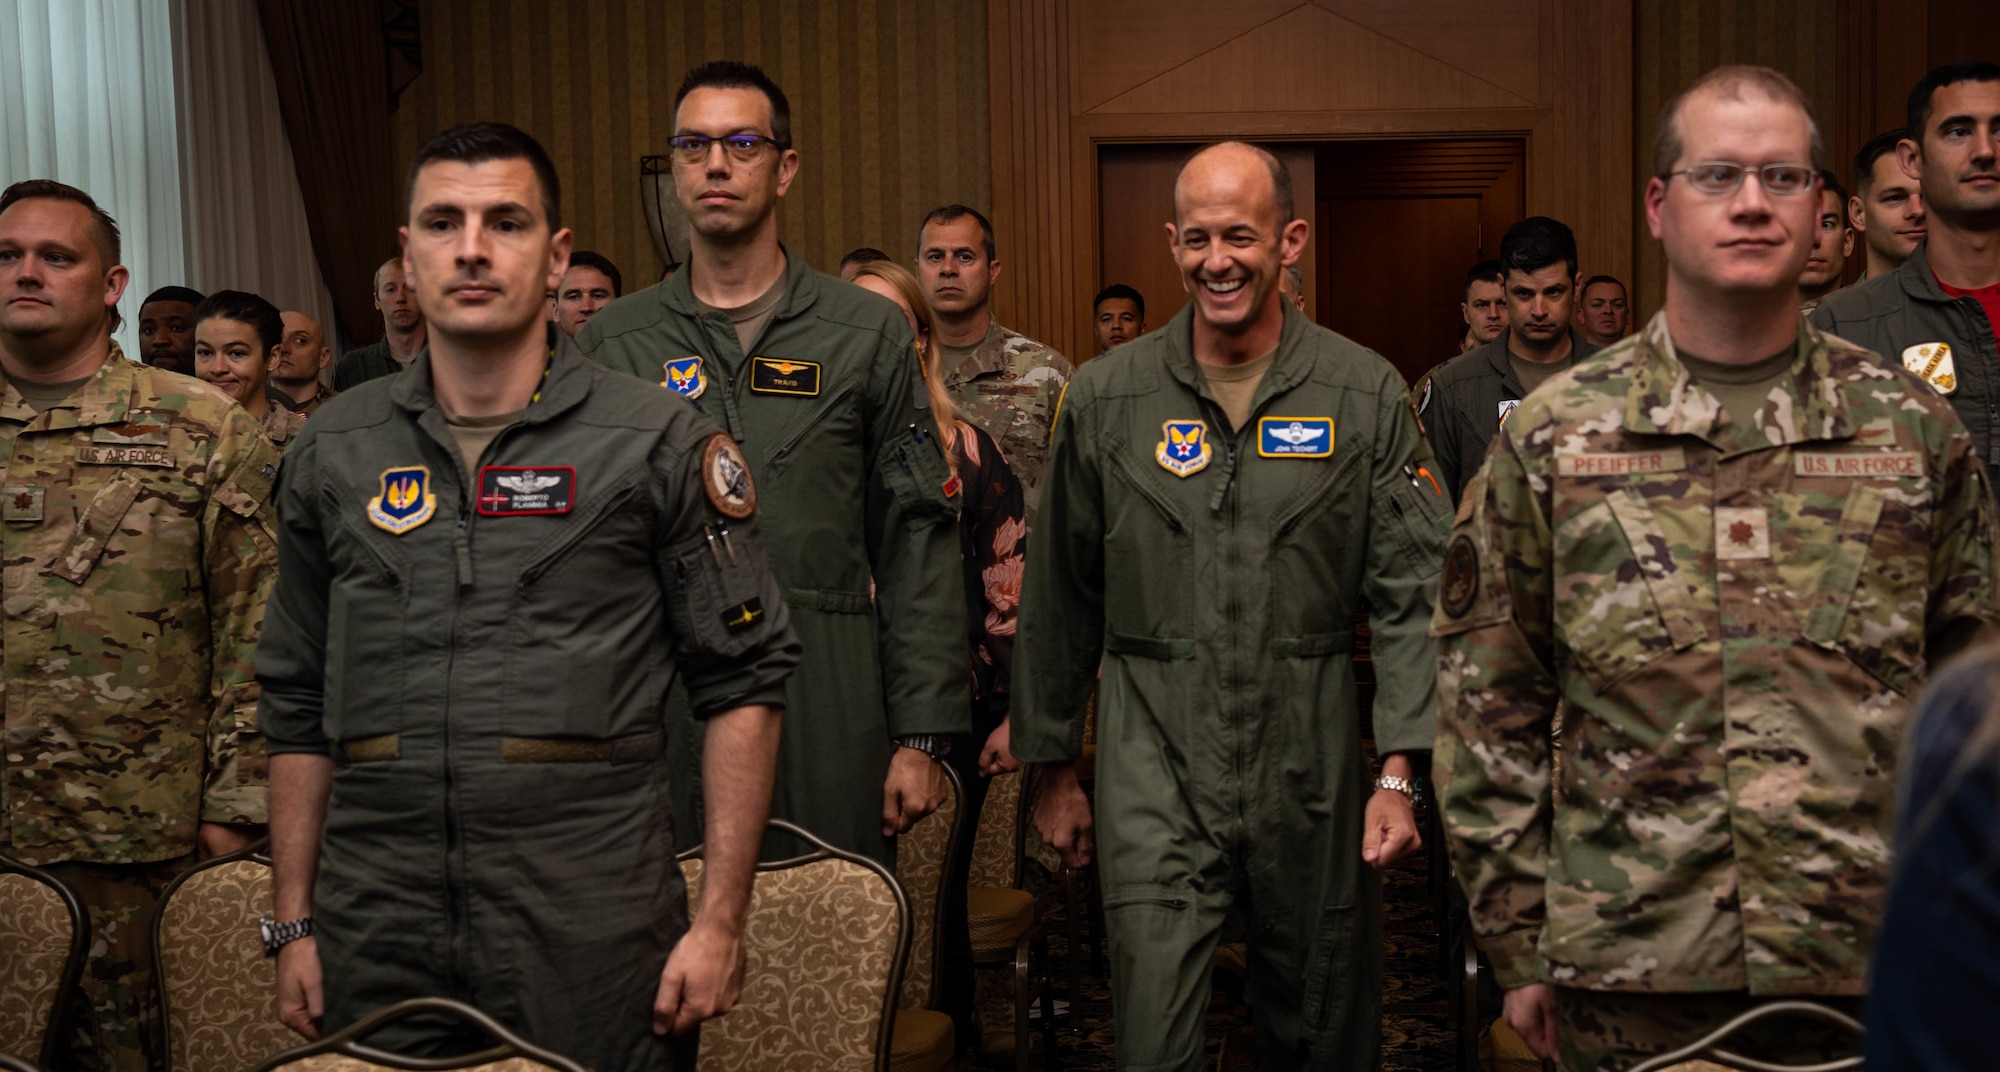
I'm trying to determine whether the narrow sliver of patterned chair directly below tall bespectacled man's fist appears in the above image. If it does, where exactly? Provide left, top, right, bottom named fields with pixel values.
left=888, top=764, right=966, bottom=1072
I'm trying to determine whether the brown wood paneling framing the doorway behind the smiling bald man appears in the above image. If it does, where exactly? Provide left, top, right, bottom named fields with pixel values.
left=988, top=0, right=1636, bottom=366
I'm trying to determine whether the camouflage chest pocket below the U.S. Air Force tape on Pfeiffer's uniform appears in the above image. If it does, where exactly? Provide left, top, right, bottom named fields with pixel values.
left=1800, top=482, right=1928, bottom=692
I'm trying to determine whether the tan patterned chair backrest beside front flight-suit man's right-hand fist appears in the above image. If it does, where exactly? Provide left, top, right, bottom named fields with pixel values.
left=680, top=820, right=910, bottom=1072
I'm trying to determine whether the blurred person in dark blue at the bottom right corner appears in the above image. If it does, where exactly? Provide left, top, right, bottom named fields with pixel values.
left=1866, top=646, right=2000, bottom=1072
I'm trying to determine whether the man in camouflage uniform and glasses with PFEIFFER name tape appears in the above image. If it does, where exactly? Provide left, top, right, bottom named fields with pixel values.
left=1432, top=68, right=1996, bottom=1068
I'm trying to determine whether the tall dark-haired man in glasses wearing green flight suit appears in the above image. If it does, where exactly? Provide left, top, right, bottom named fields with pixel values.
left=576, top=62, right=972, bottom=862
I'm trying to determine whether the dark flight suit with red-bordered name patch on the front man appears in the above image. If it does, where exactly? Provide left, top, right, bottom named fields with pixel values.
left=256, top=340, right=798, bottom=1072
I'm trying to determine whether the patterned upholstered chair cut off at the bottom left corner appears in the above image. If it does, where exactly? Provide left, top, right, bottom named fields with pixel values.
left=0, top=856, right=90, bottom=1064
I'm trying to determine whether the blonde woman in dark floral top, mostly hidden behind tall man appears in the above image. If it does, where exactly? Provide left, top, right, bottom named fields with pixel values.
left=854, top=260, right=1028, bottom=1038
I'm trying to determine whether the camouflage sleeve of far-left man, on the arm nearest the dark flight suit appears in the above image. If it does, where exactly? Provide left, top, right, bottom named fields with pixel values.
left=202, top=410, right=278, bottom=822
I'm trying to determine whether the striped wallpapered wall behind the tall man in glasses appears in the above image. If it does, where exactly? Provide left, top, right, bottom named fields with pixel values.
left=384, top=0, right=992, bottom=298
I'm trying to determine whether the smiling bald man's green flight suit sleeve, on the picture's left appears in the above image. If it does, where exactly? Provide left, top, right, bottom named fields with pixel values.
left=1010, top=370, right=1104, bottom=764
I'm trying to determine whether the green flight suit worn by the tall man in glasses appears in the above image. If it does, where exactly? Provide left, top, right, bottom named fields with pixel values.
left=576, top=254, right=972, bottom=864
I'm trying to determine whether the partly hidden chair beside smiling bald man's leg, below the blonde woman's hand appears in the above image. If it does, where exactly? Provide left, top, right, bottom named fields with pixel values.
left=966, top=770, right=1056, bottom=1072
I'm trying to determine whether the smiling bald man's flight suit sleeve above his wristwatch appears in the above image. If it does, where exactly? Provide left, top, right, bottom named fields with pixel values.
left=1362, top=370, right=1452, bottom=756
